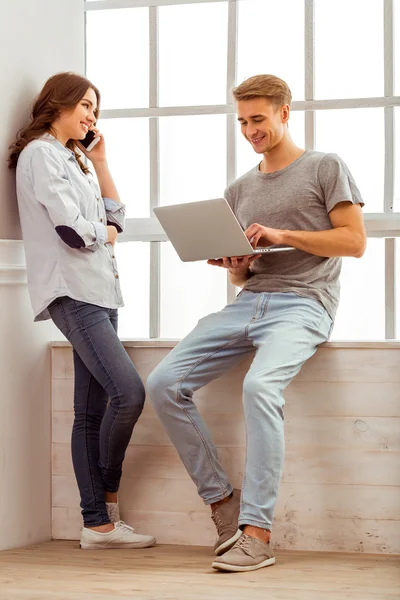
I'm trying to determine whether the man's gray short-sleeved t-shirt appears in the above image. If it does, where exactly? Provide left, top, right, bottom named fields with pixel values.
left=225, top=150, right=364, bottom=319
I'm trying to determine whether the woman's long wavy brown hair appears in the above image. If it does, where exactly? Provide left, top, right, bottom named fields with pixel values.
left=8, top=73, right=100, bottom=174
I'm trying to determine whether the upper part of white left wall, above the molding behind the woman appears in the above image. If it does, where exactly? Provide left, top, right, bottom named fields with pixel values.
left=0, top=0, right=84, bottom=239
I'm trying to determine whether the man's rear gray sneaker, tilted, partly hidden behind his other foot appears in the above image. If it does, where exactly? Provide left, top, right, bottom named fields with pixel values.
left=211, top=490, right=242, bottom=556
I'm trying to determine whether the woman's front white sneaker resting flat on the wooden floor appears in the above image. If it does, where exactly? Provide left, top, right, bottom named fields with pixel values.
left=81, top=521, right=156, bottom=550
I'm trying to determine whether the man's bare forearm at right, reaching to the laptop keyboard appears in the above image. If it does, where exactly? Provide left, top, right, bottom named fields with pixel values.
left=282, top=227, right=365, bottom=258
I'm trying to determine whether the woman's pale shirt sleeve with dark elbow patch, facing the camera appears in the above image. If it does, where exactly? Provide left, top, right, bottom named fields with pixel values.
left=30, top=146, right=107, bottom=251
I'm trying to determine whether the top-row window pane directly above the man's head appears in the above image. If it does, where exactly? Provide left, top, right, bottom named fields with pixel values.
left=237, top=0, right=304, bottom=100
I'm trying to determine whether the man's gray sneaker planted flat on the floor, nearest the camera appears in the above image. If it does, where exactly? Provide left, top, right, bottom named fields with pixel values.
left=212, top=533, right=275, bottom=572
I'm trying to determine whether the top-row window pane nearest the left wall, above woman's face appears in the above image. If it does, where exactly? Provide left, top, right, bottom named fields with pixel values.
left=86, top=8, right=149, bottom=109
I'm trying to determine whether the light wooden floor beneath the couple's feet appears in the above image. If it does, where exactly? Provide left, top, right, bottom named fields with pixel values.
left=0, top=541, right=400, bottom=600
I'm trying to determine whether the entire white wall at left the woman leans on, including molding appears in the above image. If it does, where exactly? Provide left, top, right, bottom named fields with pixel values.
left=0, top=0, right=84, bottom=550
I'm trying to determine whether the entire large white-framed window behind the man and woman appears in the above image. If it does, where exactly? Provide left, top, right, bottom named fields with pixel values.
left=84, top=0, right=400, bottom=339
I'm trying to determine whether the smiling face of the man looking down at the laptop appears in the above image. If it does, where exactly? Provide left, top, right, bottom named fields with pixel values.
left=237, top=98, right=289, bottom=154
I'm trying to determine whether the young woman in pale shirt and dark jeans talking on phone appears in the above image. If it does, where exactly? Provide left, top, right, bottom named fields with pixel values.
left=9, top=73, right=155, bottom=548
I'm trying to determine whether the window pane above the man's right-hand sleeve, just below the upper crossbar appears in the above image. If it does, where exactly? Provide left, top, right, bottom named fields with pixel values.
left=316, top=108, right=385, bottom=212
